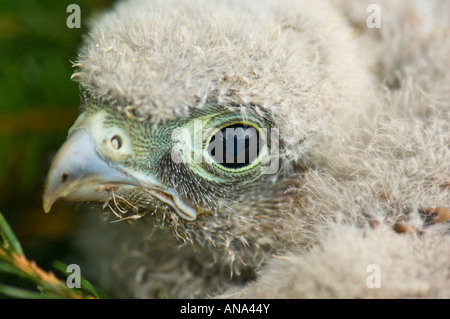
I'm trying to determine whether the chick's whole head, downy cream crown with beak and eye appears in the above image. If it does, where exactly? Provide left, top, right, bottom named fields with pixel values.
left=44, top=1, right=366, bottom=268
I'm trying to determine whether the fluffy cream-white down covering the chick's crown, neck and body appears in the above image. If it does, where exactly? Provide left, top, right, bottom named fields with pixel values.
left=54, top=0, right=450, bottom=298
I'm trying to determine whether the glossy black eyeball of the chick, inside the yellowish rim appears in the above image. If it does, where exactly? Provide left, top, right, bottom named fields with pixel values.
left=208, top=124, right=261, bottom=169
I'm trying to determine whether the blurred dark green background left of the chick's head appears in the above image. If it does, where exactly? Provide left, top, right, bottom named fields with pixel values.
left=0, top=0, right=113, bottom=296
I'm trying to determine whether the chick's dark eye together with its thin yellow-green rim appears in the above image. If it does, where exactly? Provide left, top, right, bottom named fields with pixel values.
left=205, top=122, right=266, bottom=172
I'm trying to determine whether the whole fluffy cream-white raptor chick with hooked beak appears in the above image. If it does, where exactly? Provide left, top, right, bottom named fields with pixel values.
left=44, top=0, right=450, bottom=298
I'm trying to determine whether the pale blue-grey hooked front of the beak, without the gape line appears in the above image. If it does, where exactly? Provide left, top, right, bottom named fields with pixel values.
left=43, top=128, right=140, bottom=213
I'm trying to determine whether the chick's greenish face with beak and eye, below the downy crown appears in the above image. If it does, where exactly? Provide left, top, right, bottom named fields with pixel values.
left=44, top=103, right=292, bottom=228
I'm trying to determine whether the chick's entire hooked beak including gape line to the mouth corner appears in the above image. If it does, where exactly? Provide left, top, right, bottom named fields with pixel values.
left=43, top=113, right=197, bottom=221
